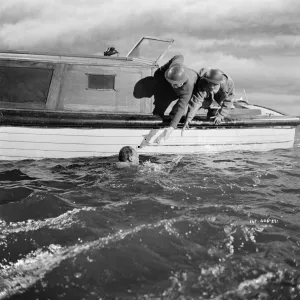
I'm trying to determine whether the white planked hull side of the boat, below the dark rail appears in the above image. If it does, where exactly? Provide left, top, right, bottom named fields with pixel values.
left=0, top=126, right=295, bottom=160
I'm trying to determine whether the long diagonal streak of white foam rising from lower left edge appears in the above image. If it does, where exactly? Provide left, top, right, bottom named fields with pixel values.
left=0, top=218, right=183, bottom=299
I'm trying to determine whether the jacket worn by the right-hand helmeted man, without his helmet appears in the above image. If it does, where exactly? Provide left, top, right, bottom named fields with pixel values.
left=187, top=68, right=235, bottom=122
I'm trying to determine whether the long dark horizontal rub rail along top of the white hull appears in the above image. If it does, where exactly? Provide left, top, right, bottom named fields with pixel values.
left=0, top=109, right=300, bottom=129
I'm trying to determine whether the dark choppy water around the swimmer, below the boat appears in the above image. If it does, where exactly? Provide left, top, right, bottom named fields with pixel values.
left=0, top=128, right=300, bottom=300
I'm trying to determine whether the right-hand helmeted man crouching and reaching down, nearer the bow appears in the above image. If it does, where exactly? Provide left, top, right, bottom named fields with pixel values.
left=183, top=68, right=235, bottom=130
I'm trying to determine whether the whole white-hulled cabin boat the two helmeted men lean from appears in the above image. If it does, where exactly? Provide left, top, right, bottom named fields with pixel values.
left=0, top=37, right=300, bottom=160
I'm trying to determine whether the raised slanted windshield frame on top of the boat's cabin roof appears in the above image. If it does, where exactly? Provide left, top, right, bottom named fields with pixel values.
left=127, top=37, right=174, bottom=64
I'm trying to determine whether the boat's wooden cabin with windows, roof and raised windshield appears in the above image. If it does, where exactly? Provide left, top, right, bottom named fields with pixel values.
left=0, top=37, right=173, bottom=114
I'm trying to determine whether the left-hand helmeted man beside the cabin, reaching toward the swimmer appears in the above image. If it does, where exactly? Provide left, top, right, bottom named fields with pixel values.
left=153, top=54, right=199, bottom=140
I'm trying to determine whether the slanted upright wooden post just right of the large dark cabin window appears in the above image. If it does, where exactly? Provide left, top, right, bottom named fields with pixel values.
left=45, top=64, right=65, bottom=110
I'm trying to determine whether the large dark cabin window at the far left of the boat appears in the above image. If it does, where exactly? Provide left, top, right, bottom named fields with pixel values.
left=0, top=66, right=53, bottom=105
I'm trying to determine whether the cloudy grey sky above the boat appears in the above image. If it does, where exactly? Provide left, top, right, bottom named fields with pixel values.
left=0, top=0, right=300, bottom=115
